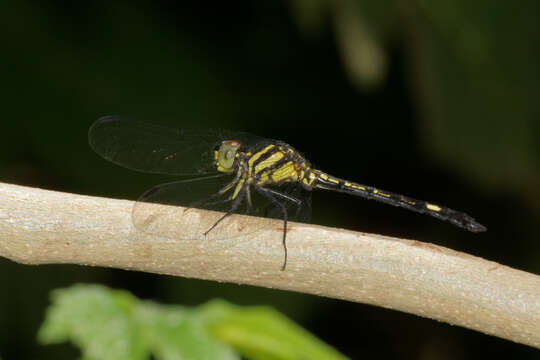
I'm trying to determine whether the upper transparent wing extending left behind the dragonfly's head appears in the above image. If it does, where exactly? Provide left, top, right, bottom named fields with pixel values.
left=88, top=116, right=265, bottom=175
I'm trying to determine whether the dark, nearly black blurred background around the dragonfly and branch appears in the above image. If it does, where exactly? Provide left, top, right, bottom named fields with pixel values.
left=0, top=0, right=540, bottom=359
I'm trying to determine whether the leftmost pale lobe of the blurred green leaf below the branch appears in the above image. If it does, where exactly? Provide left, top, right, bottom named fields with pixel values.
left=38, top=285, right=148, bottom=359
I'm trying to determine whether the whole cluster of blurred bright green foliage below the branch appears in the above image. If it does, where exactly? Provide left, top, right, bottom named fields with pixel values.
left=38, top=284, right=345, bottom=360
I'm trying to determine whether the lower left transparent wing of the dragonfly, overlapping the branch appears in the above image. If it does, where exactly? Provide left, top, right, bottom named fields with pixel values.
left=132, top=176, right=275, bottom=247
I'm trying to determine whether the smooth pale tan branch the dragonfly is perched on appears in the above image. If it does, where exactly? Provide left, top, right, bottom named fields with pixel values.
left=0, top=183, right=540, bottom=348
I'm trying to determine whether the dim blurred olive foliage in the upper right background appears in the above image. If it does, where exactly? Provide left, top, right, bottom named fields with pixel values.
left=294, top=0, right=540, bottom=191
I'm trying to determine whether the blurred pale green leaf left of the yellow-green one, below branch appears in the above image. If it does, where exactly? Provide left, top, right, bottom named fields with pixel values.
left=38, top=285, right=237, bottom=360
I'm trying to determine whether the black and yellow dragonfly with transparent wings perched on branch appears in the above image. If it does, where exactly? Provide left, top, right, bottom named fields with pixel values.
left=88, top=116, right=486, bottom=270
